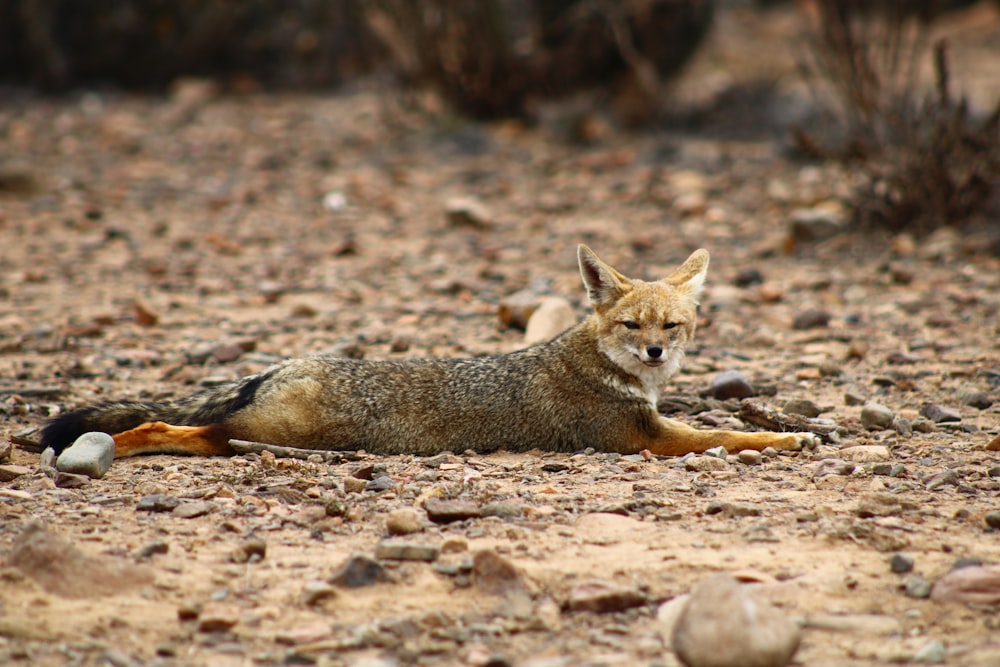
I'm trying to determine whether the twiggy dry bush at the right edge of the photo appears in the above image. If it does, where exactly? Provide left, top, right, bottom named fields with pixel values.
left=795, top=0, right=1000, bottom=233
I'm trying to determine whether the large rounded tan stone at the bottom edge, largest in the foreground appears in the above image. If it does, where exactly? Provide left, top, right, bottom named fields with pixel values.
left=671, top=574, right=802, bottom=667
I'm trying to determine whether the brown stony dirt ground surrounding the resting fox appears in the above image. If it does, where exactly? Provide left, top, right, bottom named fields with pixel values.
left=0, top=5, right=1000, bottom=667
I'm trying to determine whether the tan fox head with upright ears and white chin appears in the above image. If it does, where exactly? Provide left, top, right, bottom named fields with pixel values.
left=577, top=245, right=708, bottom=390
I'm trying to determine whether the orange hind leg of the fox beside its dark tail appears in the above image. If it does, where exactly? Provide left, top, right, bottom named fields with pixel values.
left=113, top=422, right=234, bottom=459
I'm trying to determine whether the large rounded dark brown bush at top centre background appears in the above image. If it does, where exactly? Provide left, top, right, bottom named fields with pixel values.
left=368, top=0, right=713, bottom=121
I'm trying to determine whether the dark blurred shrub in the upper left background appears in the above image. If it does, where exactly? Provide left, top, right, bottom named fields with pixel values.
left=0, top=0, right=384, bottom=91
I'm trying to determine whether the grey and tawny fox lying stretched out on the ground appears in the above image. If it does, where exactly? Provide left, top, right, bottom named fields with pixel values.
left=41, top=245, right=817, bottom=458
